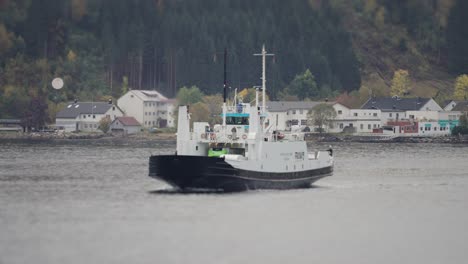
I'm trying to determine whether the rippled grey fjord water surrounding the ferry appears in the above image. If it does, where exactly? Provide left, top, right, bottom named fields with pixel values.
left=0, top=141, right=468, bottom=264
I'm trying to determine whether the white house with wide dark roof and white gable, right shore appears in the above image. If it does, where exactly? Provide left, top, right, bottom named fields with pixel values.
left=361, top=96, right=443, bottom=124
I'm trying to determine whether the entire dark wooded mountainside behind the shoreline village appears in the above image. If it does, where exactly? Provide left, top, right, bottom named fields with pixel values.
left=0, top=0, right=468, bottom=122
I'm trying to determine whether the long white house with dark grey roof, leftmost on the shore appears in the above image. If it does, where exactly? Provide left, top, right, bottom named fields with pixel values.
left=55, top=102, right=123, bottom=132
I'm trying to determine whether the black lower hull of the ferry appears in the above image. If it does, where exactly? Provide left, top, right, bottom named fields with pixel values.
left=149, top=155, right=333, bottom=191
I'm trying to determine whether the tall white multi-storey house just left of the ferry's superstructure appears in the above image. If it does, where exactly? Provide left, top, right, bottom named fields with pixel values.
left=117, top=90, right=175, bottom=128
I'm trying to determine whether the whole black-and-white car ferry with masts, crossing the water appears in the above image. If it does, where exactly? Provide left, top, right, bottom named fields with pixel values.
left=149, top=44, right=334, bottom=191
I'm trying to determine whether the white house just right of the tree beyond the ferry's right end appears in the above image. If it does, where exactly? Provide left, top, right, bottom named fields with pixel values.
left=327, top=103, right=382, bottom=133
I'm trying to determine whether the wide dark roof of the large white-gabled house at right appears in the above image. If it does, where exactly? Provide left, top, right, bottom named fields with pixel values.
left=361, top=97, right=431, bottom=111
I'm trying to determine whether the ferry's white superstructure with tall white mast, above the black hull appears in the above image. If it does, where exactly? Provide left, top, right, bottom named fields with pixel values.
left=177, top=47, right=333, bottom=173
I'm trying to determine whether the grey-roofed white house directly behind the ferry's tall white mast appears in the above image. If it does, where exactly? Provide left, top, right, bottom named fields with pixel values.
left=266, top=101, right=324, bottom=131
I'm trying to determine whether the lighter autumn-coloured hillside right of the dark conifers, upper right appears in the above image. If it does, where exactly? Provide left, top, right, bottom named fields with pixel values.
left=335, top=0, right=468, bottom=105
